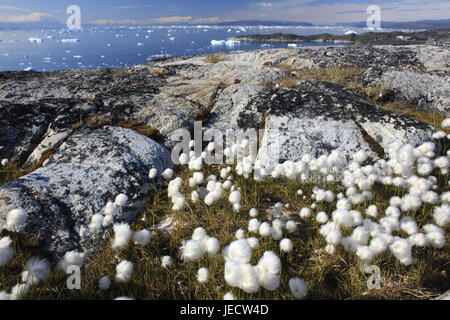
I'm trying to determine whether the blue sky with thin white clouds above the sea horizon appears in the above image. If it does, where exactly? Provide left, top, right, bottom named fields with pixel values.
left=0, top=0, right=450, bottom=24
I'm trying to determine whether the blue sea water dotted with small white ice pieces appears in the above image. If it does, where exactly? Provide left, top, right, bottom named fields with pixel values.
left=0, top=26, right=398, bottom=71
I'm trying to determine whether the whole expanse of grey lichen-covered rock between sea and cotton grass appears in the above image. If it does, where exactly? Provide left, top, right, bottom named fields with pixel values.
left=0, top=43, right=450, bottom=254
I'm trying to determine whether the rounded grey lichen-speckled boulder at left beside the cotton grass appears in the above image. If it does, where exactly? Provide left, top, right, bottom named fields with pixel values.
left=0, top=126, right=172, bottom=254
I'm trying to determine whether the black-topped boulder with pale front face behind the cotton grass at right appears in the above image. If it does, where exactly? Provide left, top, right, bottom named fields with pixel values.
left=206, top=81, right=433, bottom=166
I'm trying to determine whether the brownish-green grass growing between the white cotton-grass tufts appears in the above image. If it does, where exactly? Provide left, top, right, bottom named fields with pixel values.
left=0, top=151, right=450, bottom=300
